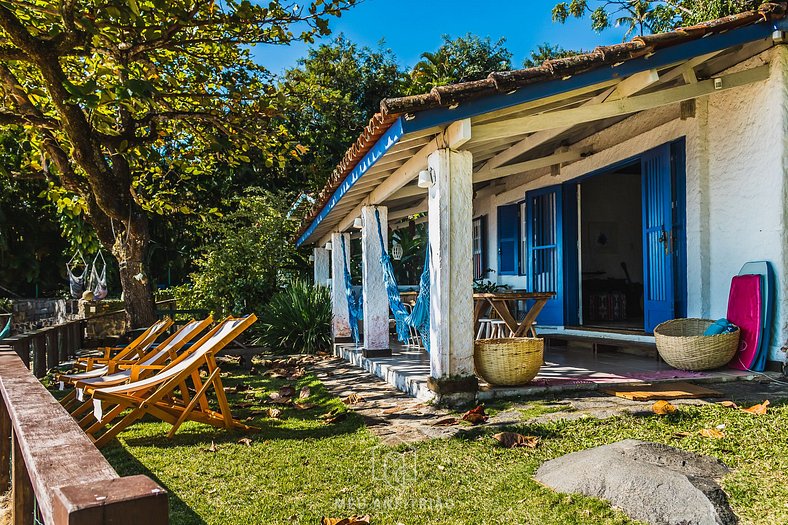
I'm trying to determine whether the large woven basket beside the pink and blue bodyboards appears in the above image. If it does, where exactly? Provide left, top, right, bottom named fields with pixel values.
left=654, top=319, right=741, bottom=371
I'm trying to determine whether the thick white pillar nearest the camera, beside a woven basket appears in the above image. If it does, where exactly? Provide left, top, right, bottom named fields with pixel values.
left=427, top=149, right=474, bottom=380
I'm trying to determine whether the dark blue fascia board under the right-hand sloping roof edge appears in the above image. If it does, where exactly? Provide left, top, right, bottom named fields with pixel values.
left=403, top=19, right=788, bottom=133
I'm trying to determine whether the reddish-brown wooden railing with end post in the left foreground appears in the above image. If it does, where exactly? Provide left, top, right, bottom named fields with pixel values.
left=0, top=346, right=168, bottom=525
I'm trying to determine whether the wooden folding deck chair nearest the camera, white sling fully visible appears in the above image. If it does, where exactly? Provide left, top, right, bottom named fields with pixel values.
left=83, top=314, right=257, bottom=448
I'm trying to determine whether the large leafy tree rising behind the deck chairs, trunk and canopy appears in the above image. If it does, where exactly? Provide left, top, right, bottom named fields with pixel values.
left=0, top=0, right=356, bottom=326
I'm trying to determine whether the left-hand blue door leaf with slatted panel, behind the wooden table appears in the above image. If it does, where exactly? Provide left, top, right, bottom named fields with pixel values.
left=525, top=186, right=564, bottom=326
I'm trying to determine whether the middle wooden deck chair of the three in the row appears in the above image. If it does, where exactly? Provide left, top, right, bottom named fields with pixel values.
left=58, top=316, right=213, bottom=417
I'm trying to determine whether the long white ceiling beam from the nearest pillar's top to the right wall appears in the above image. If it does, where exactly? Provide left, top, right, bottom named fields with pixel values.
left=473, top=64, right=769, bottom=140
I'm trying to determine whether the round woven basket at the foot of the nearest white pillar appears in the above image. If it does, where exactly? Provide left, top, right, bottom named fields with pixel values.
left=473, top=337, right=544, bottom=386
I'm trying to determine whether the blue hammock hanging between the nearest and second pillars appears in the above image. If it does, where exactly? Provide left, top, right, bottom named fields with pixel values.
left=375, top=209, right=430, bottom=352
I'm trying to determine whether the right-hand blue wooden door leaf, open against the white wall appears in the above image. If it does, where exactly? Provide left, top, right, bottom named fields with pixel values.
left=641, top=144, right=675, bottom=332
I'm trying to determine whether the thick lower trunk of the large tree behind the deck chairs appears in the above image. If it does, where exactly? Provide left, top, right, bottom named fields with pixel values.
left=112, top=204, right=156, bottom=329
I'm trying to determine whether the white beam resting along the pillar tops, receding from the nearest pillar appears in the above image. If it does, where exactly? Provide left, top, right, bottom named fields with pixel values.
left=318, top=119, right=471, bottom=246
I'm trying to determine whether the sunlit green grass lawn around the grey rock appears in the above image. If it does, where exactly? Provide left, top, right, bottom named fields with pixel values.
left=74, top=360, right=788, bottom=525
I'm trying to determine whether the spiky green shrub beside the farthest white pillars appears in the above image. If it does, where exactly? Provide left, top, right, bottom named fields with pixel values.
left=259, top=280, right=332, bottom=354
